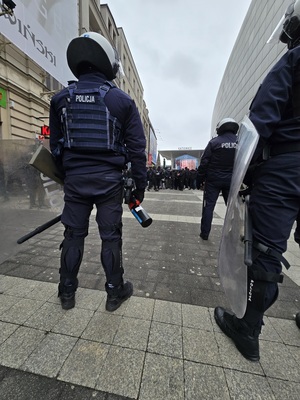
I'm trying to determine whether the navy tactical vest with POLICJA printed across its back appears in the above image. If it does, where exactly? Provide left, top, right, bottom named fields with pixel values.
left=62, top=81, right=126, bottom=154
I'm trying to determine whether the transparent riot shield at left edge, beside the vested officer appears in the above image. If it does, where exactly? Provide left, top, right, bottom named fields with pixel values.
left=0, top=139, right=63, bottom=264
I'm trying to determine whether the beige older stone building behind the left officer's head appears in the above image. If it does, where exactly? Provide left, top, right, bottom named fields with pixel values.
left=0, top=0, right=151, bottom=159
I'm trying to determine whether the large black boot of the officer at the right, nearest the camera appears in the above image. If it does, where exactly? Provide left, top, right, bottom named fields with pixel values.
left=214, top=307, right=260, bottom=361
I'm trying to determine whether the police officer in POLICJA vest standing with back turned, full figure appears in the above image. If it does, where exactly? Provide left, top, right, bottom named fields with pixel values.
left=50, top=32, right=147, bottom=311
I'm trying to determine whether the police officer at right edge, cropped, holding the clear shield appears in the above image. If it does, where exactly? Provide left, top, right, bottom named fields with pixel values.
left=215, top=0, right=300, bottom=361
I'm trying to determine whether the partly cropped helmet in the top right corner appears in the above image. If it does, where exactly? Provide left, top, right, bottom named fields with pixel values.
left=279, top=0, right=300, bottom=49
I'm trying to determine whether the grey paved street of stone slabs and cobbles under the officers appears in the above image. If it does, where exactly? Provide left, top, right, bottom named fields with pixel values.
left=0, top=190, right=300, bottom=400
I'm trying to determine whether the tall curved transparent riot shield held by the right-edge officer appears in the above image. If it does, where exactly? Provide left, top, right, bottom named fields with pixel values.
left=218, top=116, right=259, bottom=318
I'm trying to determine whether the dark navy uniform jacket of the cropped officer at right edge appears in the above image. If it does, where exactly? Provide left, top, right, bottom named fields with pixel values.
left=249, top=46, right=300, bottom=160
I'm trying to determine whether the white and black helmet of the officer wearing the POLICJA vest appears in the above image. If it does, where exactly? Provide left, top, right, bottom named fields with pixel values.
left=67, top=32, right=120, bottom=80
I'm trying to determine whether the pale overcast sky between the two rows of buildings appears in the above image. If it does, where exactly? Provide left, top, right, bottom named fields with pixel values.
left=105, top=0, right=251, bottom=150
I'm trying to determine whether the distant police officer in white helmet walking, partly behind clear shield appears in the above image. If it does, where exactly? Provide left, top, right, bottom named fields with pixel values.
left=198, top=118, right=239, bottom=240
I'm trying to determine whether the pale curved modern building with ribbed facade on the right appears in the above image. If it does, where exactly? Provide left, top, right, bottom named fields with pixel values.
left=211, top=0, right=291, bottom=136
